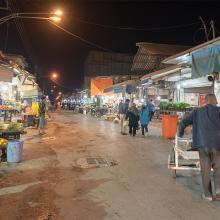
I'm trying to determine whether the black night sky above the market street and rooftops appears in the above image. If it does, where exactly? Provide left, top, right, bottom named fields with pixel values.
left=0, top=0, right=220, bottom=91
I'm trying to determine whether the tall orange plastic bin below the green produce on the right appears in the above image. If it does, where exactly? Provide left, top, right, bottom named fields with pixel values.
left=162, top=115, right=178, bottom=139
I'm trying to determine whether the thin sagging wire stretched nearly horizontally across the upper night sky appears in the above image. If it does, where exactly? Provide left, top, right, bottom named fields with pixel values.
left=74, top=18, right=199, bottom=31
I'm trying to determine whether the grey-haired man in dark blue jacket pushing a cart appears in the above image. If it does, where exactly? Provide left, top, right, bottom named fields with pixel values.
left=179, top=94, right=220, bottom=200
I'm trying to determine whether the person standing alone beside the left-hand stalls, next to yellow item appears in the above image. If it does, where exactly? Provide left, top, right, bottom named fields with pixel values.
left=38, top=96, right=47, bottom=135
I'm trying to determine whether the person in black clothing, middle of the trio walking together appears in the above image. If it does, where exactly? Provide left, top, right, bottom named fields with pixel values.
left=125, top=103, right=139, bottom=136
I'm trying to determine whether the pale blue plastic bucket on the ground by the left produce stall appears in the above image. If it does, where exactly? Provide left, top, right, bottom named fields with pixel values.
left=7, top=140, right=23, bottom=163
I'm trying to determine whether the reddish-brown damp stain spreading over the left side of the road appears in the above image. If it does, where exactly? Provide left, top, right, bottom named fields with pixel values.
left=0, top=118, right=108, bottom=220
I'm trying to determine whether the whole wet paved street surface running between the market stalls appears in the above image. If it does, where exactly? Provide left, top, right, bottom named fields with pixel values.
left=0, top=112, right=220, bottom=220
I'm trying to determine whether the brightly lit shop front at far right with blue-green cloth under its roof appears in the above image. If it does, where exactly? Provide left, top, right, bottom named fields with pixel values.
left=163, top=38, right=220, bottom=106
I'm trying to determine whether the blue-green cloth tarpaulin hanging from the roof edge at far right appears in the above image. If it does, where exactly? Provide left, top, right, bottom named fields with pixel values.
left=192, top=45, right=220, bottom=78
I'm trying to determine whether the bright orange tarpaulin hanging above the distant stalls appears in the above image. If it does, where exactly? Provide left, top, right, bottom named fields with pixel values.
left=91, top=78, right=113, bottom=96
